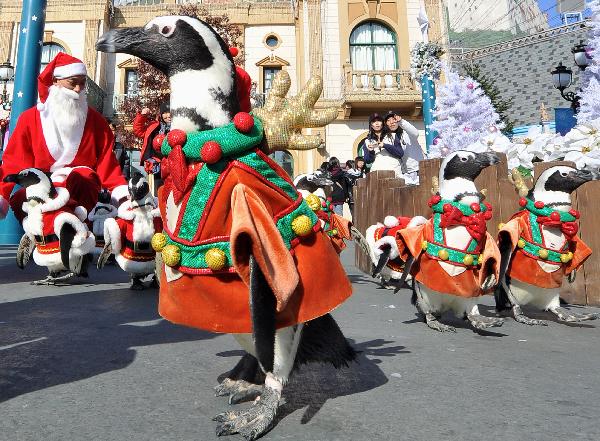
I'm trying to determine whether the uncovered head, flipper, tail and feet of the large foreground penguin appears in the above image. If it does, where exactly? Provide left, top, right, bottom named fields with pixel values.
left=97, top=16, right=355, bottom=440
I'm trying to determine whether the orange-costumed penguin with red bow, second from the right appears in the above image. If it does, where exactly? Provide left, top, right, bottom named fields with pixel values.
left=396, top=150, right=504, bottom=332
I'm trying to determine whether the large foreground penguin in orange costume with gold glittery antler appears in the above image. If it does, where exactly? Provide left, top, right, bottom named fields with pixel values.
left=97, top=16, right=355, bottom=440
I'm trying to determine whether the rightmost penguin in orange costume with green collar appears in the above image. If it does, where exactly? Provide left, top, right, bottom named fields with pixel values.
left=494, top=165, right=600, bottom=326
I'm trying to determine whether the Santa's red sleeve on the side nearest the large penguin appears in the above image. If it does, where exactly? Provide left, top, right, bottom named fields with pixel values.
left=91, top=113, right=127, bottom=191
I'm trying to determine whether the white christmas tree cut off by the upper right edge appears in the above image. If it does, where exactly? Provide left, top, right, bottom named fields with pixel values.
left=577, top=0, right=600, bottom=126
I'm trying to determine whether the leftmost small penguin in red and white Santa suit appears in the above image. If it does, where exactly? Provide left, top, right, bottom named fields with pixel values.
left=4, top=168, right=95, bottom=285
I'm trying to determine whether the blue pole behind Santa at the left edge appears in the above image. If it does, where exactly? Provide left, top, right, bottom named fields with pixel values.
left=0, top=0, right=47, bottom=245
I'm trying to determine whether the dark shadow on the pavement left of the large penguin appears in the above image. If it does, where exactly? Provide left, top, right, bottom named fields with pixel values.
left=0, top=289, right=217, bottom=402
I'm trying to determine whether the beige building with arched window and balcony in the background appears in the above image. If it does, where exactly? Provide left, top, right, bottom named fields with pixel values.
left=0, top=0, right=446, bottom=174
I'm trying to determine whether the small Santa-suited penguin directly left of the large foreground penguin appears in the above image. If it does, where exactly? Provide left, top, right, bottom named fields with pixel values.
left=98, top=173, right=162, bottom=290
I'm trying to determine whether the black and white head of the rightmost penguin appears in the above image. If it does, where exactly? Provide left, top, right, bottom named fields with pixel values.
left=528, top=165, right=600, bottom=211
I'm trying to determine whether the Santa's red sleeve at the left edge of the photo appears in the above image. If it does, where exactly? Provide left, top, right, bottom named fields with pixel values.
left=0, top=108, right=36, bottom=200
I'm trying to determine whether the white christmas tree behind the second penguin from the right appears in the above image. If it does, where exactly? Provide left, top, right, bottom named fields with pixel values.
left=429, top=72, right=502, bottom=158
